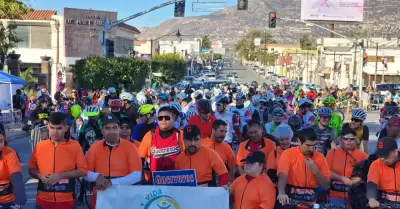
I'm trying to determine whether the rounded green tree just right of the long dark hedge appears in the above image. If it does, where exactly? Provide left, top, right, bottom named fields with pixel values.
left=151, top=54, right=187, bottom=84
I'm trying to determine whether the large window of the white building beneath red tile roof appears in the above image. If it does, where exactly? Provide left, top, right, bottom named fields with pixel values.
left=15, top=25, right=51, bottom=49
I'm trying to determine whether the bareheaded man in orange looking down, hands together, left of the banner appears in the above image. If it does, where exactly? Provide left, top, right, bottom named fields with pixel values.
left=28, top=112, right=88, bottom=209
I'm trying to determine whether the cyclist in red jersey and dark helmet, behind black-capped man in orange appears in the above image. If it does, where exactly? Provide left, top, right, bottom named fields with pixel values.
left=188, top=99, right=217, bottom=139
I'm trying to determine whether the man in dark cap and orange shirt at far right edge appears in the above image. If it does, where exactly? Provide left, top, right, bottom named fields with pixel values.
left=367, top=137, right=400, bottom=208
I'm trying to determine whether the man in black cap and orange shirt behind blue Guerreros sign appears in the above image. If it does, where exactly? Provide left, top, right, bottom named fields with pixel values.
left=175, top=125, right=229, bottom=187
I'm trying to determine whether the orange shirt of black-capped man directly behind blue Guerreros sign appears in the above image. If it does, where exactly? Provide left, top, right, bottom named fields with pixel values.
left=175, top=147, right=228, bottom=185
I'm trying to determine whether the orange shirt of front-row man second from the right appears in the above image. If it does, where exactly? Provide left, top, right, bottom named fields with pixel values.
left=326, top=148, right=368, bottom=200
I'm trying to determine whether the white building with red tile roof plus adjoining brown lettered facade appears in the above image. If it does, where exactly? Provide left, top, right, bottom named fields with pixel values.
left=1, top=8, right=140, bottom=93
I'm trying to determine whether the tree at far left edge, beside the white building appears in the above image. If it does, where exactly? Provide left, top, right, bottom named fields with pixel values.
left=0, top=0, right=29, bottom=69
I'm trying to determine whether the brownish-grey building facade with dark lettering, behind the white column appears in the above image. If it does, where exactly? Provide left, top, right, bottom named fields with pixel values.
left=63, top=8, right=117, bottom=57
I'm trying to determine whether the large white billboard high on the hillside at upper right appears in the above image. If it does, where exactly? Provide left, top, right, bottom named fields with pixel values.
left=301, top=0, right=364, bottom=22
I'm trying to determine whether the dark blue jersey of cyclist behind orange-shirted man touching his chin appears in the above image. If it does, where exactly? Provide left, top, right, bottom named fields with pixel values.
left=312, top=125, right=336, bottom=155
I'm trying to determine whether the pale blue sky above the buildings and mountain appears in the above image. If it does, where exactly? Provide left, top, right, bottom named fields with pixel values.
left=28, top=0, right=236, bottom=28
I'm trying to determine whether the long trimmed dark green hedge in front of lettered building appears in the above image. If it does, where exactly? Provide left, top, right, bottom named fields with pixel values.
left=75, top=56, right=150, bottom=91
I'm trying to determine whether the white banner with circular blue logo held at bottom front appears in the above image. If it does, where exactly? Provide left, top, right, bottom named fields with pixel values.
left=96, top=185, right=229, bottom=209
